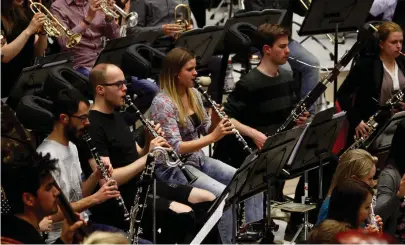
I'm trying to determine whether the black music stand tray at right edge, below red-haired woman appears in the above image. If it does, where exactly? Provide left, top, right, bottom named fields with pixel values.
left=366, top=111, right=405, bottom=154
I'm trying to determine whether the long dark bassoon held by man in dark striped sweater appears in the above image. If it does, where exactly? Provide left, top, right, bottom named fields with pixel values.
left=275, top=25, right=372, bottom=137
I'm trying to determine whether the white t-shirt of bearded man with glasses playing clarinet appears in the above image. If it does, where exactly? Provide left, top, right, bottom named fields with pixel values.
left=37, top=139, right=88, bottom=243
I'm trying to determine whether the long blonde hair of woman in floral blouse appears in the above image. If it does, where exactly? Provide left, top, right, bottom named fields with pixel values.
left=159, top=48, right=204, bottom=127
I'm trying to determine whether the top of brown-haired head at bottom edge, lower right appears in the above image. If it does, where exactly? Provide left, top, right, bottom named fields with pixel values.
left=308, top=219, right=352, bottom=244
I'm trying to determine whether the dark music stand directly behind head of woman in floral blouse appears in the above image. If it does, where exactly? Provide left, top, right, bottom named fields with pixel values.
left=174, top=26, right=224, bottom=65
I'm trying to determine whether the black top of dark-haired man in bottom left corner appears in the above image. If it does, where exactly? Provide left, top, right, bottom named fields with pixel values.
left=1, top=215, right=45, bottom=244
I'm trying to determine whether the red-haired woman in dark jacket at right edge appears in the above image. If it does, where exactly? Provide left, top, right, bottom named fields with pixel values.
left=337, top=22, right=405, bottom=143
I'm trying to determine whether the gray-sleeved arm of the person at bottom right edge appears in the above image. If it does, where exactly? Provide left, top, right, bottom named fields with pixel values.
left=375, top=171, right=401, bottom=222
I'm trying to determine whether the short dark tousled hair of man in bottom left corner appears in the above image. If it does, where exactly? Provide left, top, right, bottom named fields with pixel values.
left=1, top=152, right=58, bottom=214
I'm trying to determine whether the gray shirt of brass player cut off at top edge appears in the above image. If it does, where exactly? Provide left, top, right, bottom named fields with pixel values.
left=127, top=0, right=188, bottom=36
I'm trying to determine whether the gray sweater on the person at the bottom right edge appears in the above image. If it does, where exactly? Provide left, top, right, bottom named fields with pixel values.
left=374, top=165, right=402, bottom=235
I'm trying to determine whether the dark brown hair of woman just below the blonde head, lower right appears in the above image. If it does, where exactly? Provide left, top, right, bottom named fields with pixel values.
left=327, top=179, right=373, bottom=229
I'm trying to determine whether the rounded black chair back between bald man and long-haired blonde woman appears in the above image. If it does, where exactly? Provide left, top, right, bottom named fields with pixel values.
left=122, top=44, right=165, bottom=82
